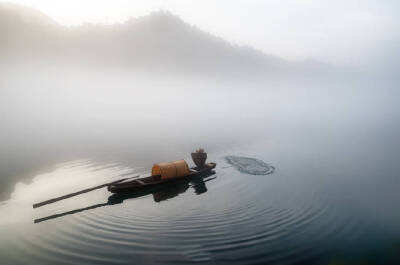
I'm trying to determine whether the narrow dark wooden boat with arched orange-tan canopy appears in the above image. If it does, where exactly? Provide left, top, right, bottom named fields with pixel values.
left=107, top=160, right=216, bottom=193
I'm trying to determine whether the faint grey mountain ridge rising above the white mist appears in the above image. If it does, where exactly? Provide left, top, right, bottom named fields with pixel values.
left=0, top=4, right=328, bottom=73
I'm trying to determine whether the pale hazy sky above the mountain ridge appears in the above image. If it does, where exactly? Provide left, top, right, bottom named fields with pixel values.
left=1, top=0, right=400, bottom=64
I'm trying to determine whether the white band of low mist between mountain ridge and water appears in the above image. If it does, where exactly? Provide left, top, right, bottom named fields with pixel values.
left=0, top=64, right=396, bottom=196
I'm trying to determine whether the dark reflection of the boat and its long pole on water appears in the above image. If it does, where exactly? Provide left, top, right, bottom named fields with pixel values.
left=33, top=170, right=216, bottom=224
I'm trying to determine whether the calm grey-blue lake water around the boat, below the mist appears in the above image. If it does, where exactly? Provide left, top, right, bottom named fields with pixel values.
left=0, top=122, right=400, bottom=264
